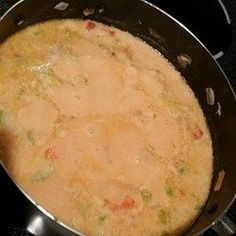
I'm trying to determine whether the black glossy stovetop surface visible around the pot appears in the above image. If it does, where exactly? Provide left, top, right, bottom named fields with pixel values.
left=0, top=0, right=236, bottom=236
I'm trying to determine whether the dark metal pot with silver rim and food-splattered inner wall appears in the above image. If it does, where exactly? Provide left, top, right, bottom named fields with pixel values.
left=0, top=0, right=236, bottom=236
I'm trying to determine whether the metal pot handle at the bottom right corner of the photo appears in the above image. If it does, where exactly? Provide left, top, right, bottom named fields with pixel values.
left=211, top=215, right=236, bottom=236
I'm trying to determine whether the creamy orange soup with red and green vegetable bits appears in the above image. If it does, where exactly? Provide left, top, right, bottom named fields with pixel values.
left=0, top=20, right=213, bottom=236
